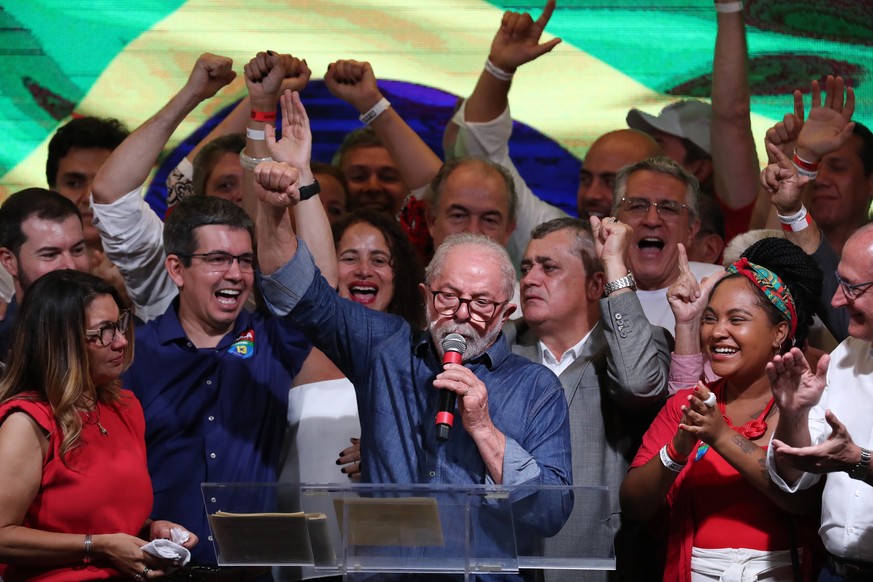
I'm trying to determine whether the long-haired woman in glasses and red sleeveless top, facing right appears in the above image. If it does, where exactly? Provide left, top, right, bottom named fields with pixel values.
left=0, top=271, right=197, bottom=582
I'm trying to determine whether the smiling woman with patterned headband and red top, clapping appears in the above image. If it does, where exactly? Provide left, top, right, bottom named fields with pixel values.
left=621, top=238, right=821, bottom=582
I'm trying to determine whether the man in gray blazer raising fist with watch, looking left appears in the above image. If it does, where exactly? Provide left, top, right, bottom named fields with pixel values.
left=504, top=218, right=672, bottom=581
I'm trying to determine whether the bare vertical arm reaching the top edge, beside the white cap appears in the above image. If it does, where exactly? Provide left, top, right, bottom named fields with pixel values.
left=710, top=0, right=759, bottom=210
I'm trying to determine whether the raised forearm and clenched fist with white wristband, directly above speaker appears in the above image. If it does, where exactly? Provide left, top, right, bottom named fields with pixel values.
left=324, top=60, right=442, bottom=190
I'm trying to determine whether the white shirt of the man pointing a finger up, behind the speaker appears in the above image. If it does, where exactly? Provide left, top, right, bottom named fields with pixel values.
left=452, top=101, right=567, bottom=265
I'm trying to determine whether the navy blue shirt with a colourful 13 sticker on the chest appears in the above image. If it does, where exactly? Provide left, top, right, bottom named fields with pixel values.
left=123, top=298, right=310, bottom=563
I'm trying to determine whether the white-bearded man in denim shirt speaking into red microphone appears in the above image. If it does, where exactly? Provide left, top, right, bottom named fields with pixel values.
left=257, top=182, right=572, bottom=552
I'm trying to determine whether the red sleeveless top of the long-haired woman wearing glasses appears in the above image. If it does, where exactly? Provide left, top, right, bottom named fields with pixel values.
left=0, top=390, right=152, bottom=582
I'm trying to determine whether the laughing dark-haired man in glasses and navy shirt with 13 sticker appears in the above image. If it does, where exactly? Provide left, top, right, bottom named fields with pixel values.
left=123, top=196, right=312, bottom=579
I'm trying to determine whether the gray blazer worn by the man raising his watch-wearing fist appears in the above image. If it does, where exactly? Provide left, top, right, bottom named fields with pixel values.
left=503, top=293, right=673, bottom=582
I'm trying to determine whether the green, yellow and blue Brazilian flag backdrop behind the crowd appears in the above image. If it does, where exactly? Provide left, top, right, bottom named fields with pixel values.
left=0, top=0, right=873, bottom=216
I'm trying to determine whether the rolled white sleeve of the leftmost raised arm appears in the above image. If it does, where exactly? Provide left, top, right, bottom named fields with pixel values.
left=91, top=187, right=178, bottom=321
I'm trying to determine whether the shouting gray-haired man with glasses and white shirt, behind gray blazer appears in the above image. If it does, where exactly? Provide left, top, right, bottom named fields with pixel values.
left=608, top=156, right=721, bottom=333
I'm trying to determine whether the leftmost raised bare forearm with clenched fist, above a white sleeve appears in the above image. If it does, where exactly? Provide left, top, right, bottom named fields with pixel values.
left=92, top=53, right=236, bottom=204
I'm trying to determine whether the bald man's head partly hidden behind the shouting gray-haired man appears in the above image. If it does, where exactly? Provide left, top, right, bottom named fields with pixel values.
left=576, top=129, right=663, bottom=217
